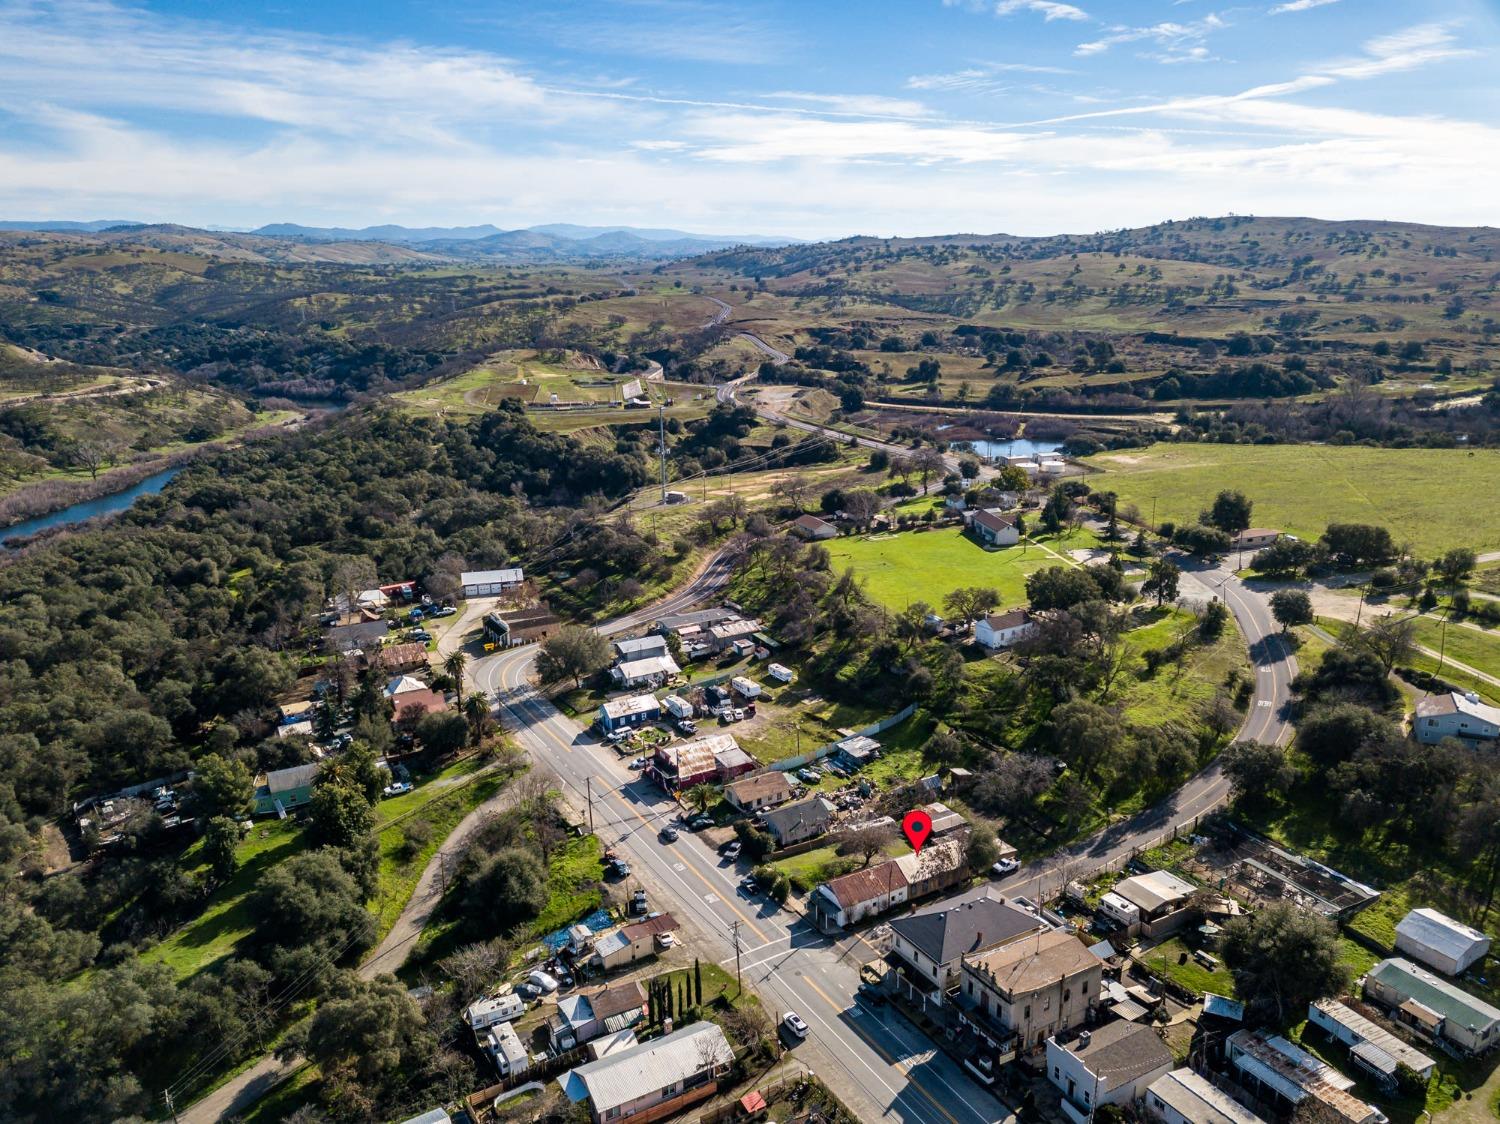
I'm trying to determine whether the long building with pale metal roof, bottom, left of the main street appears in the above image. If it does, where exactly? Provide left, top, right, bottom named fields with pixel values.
left=558, top=1022, right=735, bottom=1124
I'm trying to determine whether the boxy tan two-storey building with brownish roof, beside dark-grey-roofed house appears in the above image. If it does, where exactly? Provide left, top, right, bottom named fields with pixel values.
left=957, top=929, right=1104, bottom=1049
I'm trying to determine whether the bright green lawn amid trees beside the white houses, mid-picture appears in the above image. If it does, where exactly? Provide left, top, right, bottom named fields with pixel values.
left=825, top=527, right=1098, bottom=611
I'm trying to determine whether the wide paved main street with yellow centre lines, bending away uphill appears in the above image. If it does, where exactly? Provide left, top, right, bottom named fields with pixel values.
left=473, top=557, right=1010, bottom=1124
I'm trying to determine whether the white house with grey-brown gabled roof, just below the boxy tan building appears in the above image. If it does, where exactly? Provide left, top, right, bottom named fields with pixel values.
left=1047, top=1022, right=1173, bottom=1124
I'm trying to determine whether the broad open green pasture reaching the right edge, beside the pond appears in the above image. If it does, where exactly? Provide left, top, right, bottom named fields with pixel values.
left=1088, top=444, right=1500, bottom=558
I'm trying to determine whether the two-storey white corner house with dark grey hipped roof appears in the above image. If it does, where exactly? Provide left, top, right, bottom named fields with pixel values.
left=891, top=897, right=1047, bottom=1005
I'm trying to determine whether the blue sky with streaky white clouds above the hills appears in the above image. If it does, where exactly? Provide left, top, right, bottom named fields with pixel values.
left=0, top=0, right=1500, bottom=239
